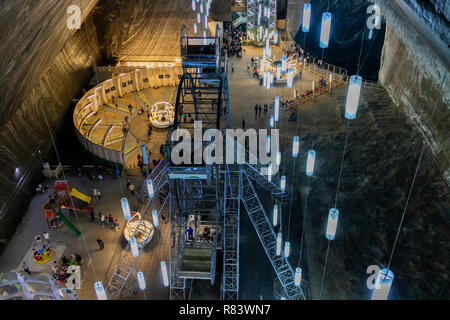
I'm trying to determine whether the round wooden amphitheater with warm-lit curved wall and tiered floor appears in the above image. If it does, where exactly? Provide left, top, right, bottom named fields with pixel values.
left=73, top=64, right=182, bottom=169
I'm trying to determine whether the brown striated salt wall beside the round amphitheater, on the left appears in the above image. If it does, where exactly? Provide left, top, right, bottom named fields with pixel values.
left=0, top=0, right=99, bottom=244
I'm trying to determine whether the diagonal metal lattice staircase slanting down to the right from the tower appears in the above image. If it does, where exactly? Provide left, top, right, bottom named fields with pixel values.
left=240, top=170, right=305, bottom=300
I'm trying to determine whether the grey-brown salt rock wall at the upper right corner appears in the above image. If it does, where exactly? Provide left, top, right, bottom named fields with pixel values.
left=379, top=0, right=450, bottom=183
